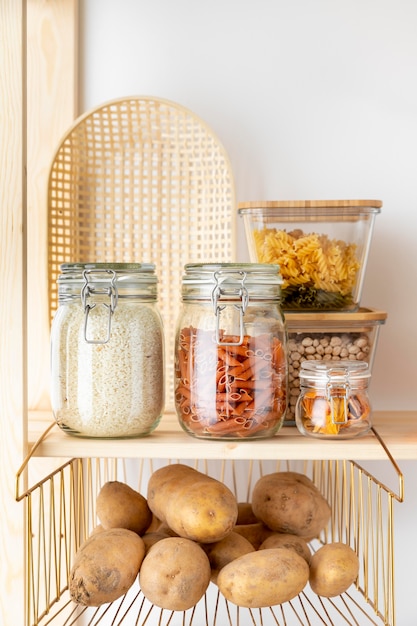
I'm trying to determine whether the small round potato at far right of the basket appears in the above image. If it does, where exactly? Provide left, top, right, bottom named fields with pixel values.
left=310, top=542, right=359, bottom=598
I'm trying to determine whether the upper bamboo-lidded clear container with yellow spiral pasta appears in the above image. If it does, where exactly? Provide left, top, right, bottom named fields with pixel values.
left=238, top=200, right=382, bottom=312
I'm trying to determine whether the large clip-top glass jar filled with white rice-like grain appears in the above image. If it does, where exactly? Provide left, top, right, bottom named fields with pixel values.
left=51, top=263, right=164, bottom=438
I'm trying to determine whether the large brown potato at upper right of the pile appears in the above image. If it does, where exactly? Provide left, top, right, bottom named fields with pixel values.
left=252, top=472, right=331, bottom=539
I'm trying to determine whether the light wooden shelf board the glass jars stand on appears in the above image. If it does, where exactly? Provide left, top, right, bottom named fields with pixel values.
left=29, top=411, right=417, bottom=461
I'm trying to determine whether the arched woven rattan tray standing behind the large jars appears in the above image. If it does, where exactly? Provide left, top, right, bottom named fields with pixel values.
left=48, top=96, right=235, bottom=409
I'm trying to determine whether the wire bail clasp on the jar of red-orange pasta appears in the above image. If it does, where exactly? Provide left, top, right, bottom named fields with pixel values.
left=211, top=270, right=249, bottom=346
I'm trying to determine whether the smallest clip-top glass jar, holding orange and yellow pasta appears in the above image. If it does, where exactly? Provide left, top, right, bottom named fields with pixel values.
left=295, top=360, right=372, bottom=439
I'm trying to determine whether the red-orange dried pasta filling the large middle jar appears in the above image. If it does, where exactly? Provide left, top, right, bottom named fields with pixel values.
left=175, top=327, right=287, bottom=438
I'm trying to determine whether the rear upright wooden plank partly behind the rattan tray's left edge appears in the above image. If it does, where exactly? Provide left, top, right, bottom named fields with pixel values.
left=27, top=0, right=78, bottom=409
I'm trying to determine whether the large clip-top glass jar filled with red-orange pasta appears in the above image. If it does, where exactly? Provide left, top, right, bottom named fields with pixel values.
left=174, top=263, right=287, bottom=439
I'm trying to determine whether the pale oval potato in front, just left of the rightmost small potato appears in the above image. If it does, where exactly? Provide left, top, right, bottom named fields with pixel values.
left=217, top=548, right=309, bottom=609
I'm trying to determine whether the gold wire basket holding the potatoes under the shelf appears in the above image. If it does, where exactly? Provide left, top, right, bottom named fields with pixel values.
left=16, top=429, right=404, bottom=626
